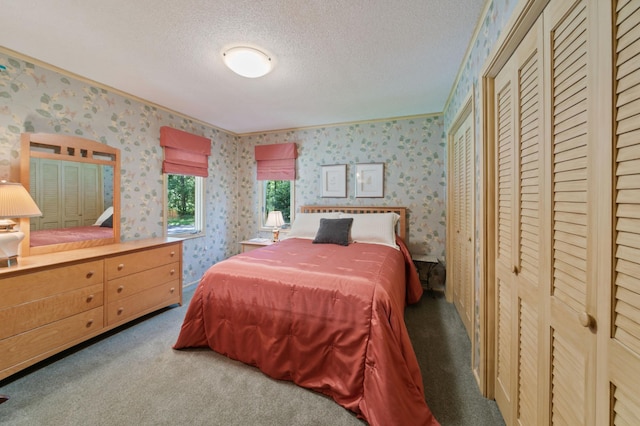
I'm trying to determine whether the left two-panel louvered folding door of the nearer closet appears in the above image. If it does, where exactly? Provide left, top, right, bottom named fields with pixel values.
left=496, top=15, right=544, bottom=425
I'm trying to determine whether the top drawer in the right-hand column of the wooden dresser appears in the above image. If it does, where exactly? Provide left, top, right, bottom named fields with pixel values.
left=106, top=244, right=181, bottom=280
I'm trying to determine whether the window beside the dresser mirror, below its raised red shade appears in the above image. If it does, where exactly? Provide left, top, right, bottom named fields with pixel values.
left=164, top=173, right=204, bottom=237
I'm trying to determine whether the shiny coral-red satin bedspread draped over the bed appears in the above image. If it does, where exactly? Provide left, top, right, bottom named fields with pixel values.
left=174, top=238, right=438, bottom=426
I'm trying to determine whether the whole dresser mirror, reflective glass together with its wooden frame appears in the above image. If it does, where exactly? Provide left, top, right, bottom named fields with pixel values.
left=20, top=133, right=120, bottom=256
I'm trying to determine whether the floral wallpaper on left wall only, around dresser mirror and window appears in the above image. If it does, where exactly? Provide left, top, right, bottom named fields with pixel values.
left=0, top=51, right=238, bottom=285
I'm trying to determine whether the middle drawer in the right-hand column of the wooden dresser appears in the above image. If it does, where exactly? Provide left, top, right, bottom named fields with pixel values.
left=107, top=262, right=180, bottom=302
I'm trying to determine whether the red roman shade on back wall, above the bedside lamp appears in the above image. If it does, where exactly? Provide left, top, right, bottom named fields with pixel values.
left=255, top=142, right=298, bottom=180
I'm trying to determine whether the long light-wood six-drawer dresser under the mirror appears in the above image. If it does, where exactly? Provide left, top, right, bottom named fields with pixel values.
left=0, top=238, right=182, bottom=380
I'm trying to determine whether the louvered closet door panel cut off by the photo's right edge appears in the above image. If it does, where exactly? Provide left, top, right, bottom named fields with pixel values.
left=599, top=0, right=640, bottom=425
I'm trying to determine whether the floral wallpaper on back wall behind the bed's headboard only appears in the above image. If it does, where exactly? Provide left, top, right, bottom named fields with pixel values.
left=238, top=115, right=446, bottom=258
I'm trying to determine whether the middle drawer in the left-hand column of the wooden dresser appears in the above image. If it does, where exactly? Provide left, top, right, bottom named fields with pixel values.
left=0, top=283, right=103, bottom=339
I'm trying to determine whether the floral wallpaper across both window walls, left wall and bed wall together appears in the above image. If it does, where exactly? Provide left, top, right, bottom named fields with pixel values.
left=0, top=50, right=446, bottom=285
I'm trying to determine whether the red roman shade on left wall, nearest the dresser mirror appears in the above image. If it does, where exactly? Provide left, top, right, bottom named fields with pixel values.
left=160, top=126, right=211, bottom=177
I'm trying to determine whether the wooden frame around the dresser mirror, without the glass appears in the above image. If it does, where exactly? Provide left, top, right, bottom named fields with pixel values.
left=20, top=133, right=120, bottom=256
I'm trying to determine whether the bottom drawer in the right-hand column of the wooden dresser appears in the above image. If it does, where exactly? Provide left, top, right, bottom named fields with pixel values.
left=107, top=279, right=182, bottom=326
